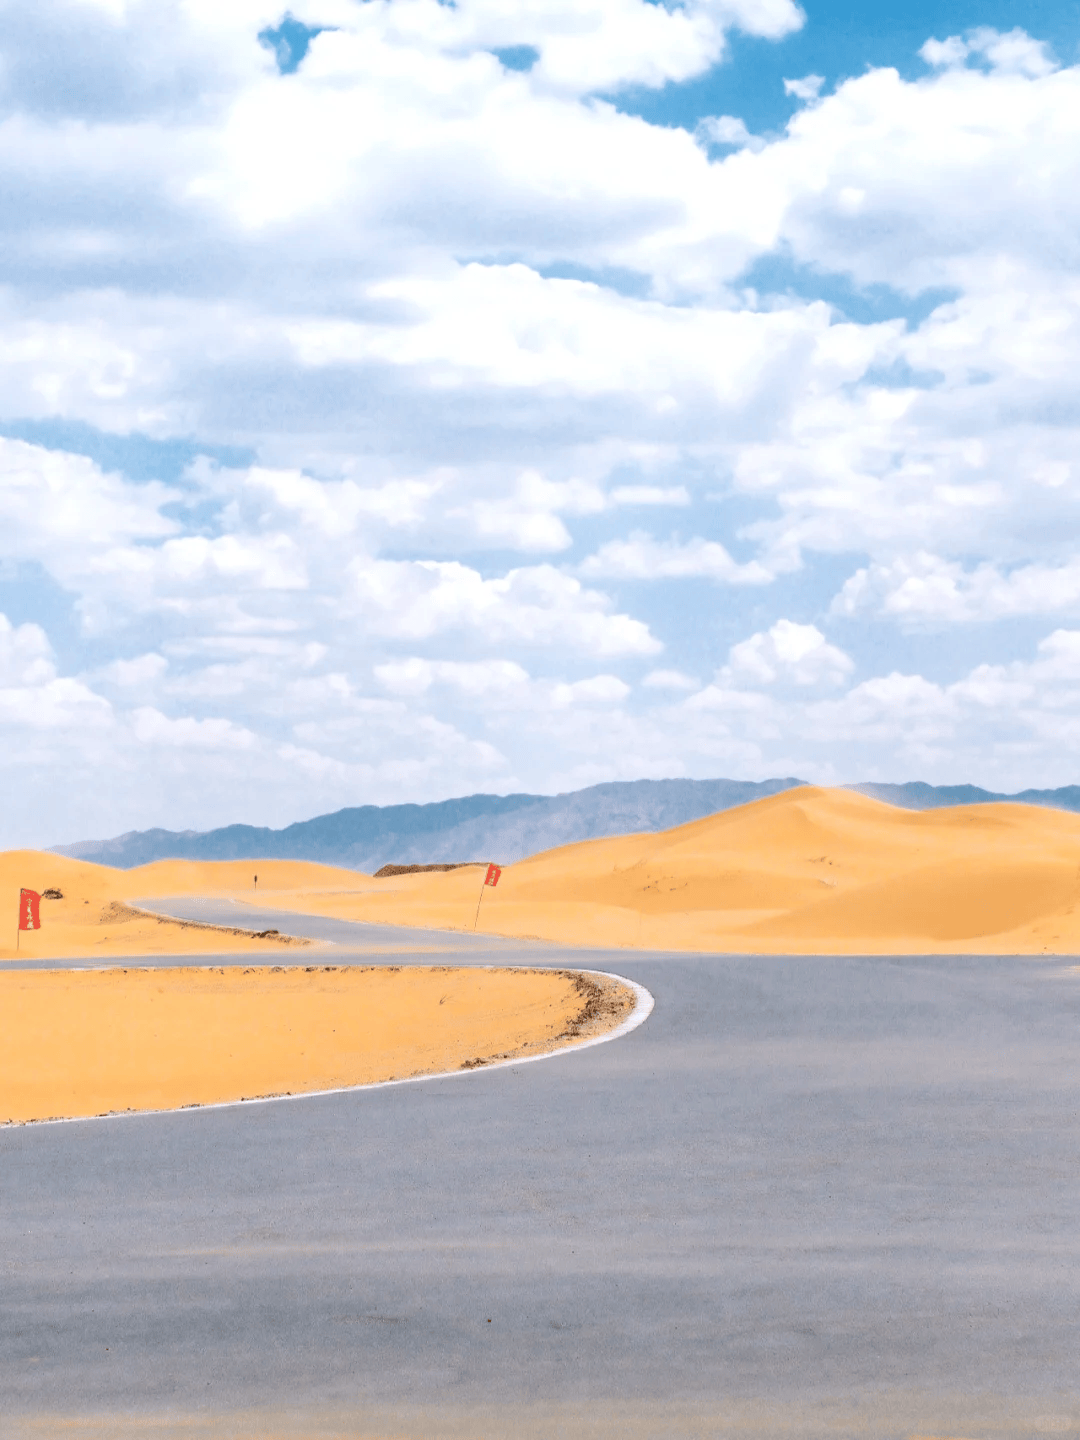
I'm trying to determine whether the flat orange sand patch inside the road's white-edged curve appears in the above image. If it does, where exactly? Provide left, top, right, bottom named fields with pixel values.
left=0, top=965, right=635, bottom=1123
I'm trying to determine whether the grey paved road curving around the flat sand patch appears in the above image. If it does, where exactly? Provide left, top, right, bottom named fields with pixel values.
left=0, top=910, right=1080, bottom=1440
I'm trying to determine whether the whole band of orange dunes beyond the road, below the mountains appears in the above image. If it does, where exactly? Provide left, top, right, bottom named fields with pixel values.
left=10, top=788, right=1080, bottom=960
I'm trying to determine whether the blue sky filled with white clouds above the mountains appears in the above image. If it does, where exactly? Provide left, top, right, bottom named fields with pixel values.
left=0, top=0, right=1080, bottom=848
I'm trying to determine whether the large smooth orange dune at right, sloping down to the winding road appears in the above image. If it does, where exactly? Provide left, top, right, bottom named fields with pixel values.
left=253, top=788, right=1080, bottom=953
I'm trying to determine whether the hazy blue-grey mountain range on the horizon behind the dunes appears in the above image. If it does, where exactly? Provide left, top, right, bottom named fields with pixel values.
left=53, top=778, right=1080, bottom=874
